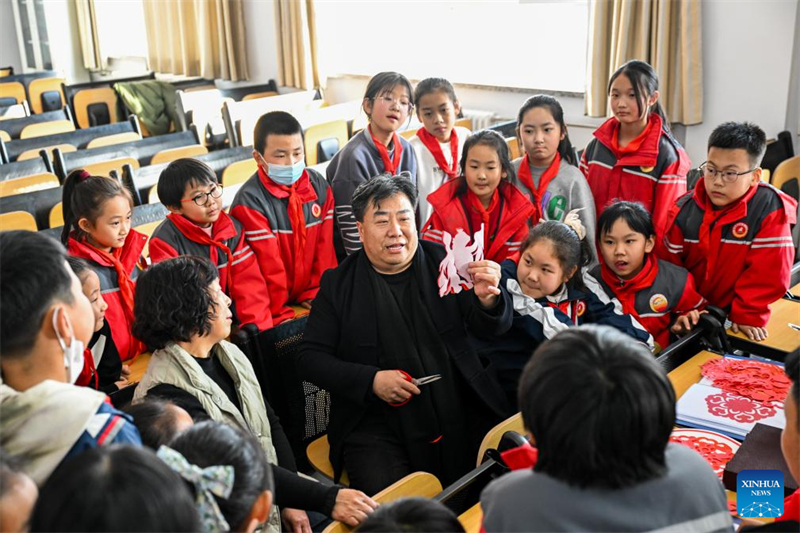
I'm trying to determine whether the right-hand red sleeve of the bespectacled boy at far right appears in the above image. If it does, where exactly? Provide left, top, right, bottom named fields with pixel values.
left=728, top=209, right=794, bottom=327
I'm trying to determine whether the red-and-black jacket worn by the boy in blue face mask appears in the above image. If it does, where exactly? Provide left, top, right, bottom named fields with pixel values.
left=231, top=168, right=337, bottom=326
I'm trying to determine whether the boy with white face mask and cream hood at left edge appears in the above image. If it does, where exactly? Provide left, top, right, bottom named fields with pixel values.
left=0, top=231, right=141, bottom=485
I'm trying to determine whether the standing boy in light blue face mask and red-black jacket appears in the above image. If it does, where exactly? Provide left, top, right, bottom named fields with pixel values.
left=231, top=111, right=336, bottom=325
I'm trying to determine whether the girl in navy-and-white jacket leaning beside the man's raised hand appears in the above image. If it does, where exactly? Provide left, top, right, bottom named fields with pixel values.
left=473, top=211, right=653, bottom=405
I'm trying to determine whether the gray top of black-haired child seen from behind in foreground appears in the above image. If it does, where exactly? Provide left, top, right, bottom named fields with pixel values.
left=481, top=443, right=732, bottom=533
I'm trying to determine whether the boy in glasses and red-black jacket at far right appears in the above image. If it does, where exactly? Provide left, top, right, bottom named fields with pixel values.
left=659, top=122, right=797, bottom=341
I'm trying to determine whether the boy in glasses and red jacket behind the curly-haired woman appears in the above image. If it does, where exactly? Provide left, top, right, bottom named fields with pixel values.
left=150, top=159, right=272, bottom=331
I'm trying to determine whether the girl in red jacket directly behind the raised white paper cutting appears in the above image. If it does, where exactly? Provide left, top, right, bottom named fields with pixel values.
left=422, top=130, right=534, bottom=263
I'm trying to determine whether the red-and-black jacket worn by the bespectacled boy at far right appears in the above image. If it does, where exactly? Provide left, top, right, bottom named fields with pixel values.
left=659, top=180, right=797, bottom=327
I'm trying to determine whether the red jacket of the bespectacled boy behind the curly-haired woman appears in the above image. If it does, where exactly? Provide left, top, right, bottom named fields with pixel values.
left=150, top=211, right=272, bottom=331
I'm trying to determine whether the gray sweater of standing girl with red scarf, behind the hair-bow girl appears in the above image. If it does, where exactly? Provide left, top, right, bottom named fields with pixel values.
left=514, top=157, right=597, bottom=264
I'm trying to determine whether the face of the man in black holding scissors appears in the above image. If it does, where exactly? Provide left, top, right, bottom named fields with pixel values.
left=357, top=193, right=417, bottom=274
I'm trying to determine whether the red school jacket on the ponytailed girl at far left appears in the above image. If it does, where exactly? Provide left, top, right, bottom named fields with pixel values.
left=67, top=229, right=147, bottom=361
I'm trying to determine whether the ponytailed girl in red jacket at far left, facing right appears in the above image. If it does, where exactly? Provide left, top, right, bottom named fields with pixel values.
left=61, top=169, right=147, bottom=362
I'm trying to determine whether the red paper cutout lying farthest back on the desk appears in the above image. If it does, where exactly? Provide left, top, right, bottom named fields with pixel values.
left=702, top=358, right=792, bottom=405
